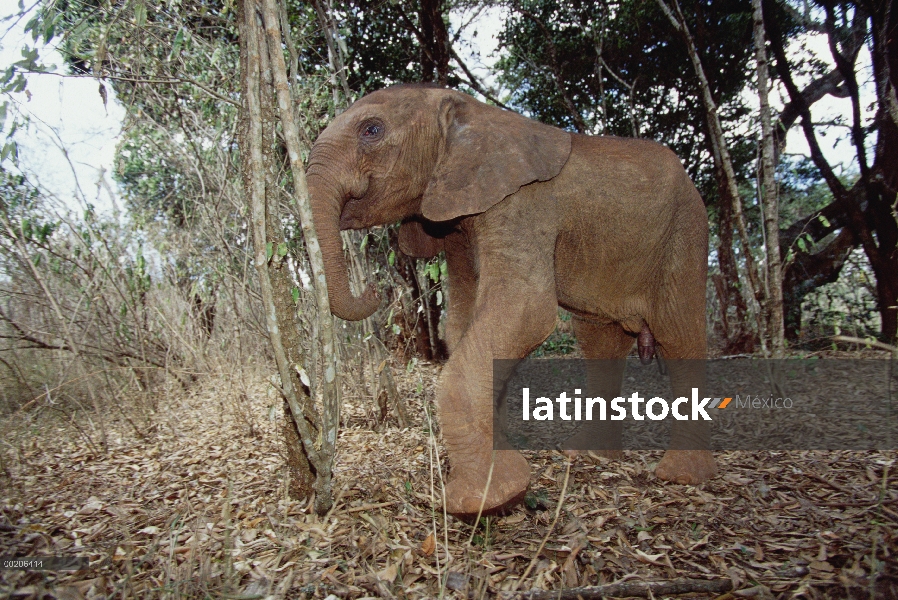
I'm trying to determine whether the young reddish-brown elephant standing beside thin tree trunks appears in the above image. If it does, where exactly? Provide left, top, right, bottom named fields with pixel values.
left=307, top=84, right=716, bottom=515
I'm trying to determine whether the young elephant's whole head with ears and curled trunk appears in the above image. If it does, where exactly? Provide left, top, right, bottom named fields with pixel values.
left=307, top=85, right=571, bottom=320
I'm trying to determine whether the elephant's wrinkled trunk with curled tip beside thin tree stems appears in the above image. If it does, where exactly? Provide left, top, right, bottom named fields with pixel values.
left=308, top=173, right=380, bottom=321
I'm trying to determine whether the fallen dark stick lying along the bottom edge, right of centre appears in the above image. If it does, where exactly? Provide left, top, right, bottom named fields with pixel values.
left=499, top=578, right=733, bottom=600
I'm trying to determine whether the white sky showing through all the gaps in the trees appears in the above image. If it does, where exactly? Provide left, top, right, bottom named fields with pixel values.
left=0, top=0, right=874, bottom=211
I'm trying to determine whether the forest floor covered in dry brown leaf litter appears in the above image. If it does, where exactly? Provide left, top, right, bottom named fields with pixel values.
left=0, top=354, right=898, bottom=600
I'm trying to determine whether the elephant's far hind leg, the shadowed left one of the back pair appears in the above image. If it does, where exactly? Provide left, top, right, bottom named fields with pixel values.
left=564, top=316, right=633, bottom=458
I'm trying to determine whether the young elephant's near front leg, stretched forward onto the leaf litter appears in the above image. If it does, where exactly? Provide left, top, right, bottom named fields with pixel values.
left=437, top=268, right=557, bottom=515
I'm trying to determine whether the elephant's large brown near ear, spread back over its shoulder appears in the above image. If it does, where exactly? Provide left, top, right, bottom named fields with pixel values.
left=421, top=92, right=571, bottom=221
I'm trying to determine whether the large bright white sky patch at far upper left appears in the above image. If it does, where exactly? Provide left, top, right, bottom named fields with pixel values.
left=0, top=0, right=125, bottom=211
